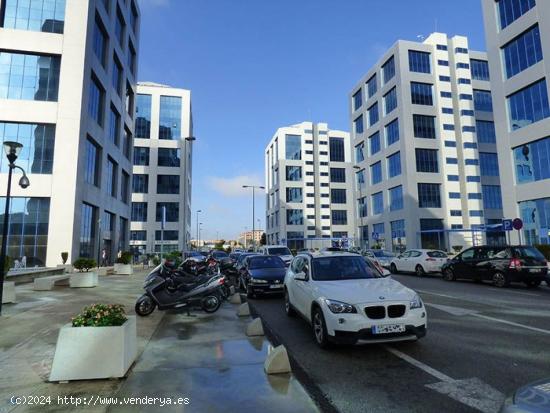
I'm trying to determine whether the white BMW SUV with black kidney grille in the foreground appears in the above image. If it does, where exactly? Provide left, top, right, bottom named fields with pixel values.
left=284, top=253, right=428, bottom=348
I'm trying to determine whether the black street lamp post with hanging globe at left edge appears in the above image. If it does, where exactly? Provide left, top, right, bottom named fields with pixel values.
left=0, top=141, right=31, bottom=314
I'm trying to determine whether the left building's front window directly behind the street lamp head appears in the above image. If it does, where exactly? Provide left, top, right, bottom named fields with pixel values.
left=0, top=122, right=55, bottom=174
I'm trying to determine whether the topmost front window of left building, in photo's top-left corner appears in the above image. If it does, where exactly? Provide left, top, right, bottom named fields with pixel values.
left=2, top=0, right=65, bottom=33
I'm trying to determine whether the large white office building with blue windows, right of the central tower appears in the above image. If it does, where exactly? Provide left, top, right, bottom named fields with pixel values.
left=349, top=33, right=502, bottom=250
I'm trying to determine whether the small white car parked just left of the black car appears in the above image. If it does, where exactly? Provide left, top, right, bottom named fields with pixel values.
left=390, top=249, right=448, bottom=277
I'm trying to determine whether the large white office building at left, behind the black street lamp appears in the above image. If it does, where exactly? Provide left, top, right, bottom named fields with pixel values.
left=0, top=0, right=140, bottom=266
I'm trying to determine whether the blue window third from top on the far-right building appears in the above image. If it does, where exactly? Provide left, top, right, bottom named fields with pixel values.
left=507, top=79, right=550, bottom=130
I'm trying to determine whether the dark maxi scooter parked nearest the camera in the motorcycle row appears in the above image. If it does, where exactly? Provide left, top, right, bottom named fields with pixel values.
left=135, top=264, right=225, bottom=317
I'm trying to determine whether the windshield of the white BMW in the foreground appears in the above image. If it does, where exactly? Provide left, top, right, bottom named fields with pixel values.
left=312, top=257, right=380, bottom=281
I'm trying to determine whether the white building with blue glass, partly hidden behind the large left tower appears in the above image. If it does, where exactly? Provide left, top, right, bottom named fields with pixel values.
left=130, top=82, right=193, bottom=255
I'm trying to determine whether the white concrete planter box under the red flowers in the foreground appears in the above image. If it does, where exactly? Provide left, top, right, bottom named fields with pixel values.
left=50, top=316, right=137, bottom=381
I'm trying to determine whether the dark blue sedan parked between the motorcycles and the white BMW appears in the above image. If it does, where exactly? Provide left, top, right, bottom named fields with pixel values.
left=240, top=255, right=286, bottom=298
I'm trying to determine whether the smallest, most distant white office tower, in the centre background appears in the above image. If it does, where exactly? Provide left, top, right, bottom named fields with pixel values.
left=265, top=122, right=354, bottom=249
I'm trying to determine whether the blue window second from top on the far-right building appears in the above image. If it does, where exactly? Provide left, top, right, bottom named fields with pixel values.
left=502, top=25, right=542, bottom=78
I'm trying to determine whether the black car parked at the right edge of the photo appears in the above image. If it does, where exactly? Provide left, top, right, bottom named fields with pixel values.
left=442, top=245, right=548, bottom=287
